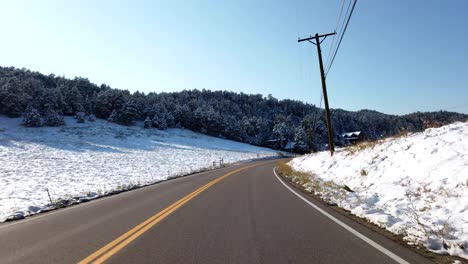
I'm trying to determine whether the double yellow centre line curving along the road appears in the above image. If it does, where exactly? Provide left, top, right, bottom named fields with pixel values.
left=78, top=162, right=267, bottom=264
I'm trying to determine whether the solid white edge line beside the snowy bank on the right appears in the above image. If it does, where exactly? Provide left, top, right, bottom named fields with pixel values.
left=273, top=168, right=409, bottom=264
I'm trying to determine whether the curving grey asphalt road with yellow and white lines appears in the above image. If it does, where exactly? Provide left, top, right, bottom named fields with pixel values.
left=0, top=161, right=429, bottom=264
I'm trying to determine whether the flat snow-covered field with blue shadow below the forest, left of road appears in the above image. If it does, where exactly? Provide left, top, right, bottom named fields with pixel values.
left=0, top=116, right=277, bottom=221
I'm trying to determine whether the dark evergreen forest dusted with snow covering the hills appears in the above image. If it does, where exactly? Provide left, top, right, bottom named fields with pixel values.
left=0, top=67, right=468, bottom=153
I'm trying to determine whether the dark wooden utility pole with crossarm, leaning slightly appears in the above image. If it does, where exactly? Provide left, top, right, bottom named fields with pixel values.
left=297, top=32, right=336, bottom=156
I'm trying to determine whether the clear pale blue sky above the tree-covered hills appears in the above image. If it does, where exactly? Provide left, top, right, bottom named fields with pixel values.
left=0, top=0, right=468, bottom=114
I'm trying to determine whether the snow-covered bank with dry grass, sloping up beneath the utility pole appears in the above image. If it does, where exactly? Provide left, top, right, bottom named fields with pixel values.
left=289, top=122, right=468, bottom=258
